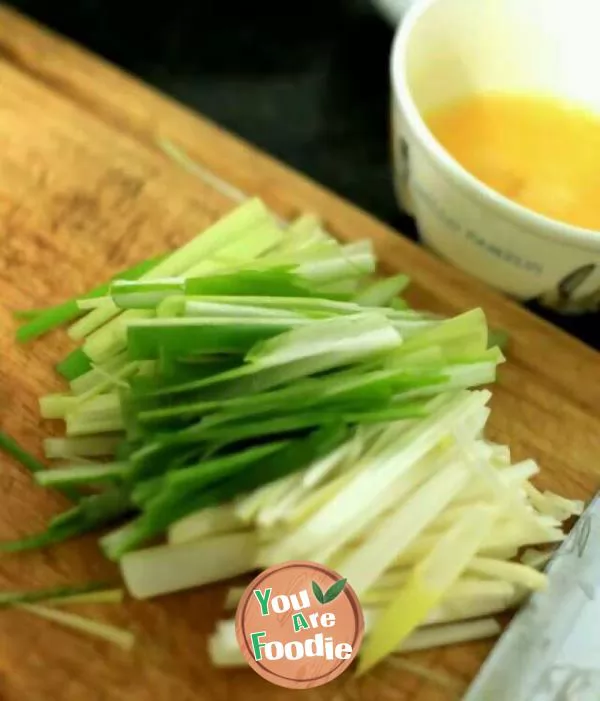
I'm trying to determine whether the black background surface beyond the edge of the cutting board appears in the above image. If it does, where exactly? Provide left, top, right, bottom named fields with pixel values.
left=5, top=0, right=600, bottom=348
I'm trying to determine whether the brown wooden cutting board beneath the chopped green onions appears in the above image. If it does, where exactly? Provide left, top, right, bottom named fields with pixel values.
left=0, top=8, right=600, bottom=701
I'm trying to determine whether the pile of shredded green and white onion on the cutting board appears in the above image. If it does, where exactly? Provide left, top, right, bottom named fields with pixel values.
left=5, top=200, right=581, bottom=670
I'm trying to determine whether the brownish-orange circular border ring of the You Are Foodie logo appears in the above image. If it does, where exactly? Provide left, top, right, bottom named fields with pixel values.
left=235, top=560, right=365, bottom=689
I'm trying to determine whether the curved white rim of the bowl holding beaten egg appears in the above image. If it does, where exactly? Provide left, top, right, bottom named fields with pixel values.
left=390, top=0, right=600, bottom=253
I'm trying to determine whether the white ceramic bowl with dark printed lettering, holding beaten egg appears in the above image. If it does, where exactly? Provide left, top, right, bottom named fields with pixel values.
left=391, top=0, right=600, bottom=312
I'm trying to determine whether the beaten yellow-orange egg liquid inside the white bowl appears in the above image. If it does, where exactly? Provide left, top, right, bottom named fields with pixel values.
left=425, top=94, right=600, bottom=231
